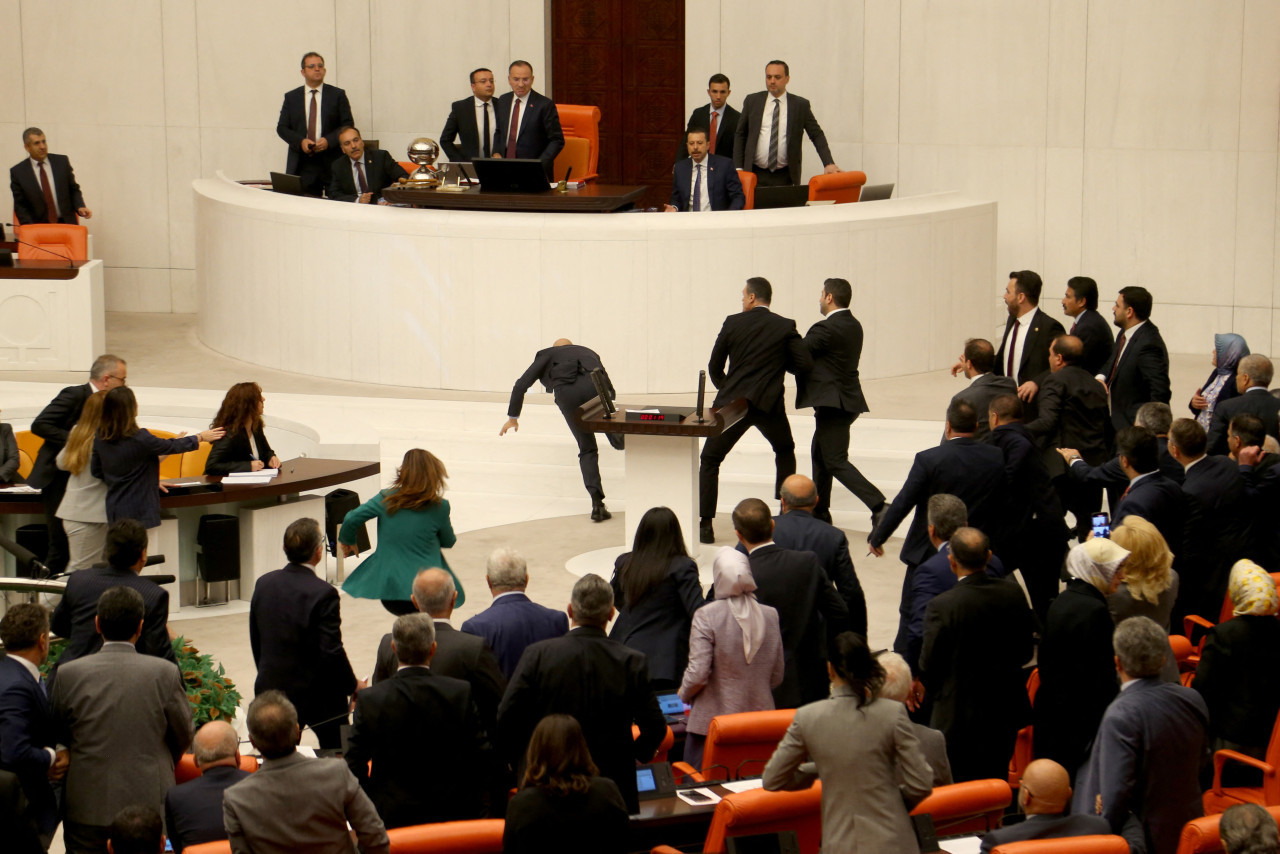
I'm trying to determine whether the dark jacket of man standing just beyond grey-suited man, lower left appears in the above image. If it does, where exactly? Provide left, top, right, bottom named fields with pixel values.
left=50, top=565, right=178, bottom=673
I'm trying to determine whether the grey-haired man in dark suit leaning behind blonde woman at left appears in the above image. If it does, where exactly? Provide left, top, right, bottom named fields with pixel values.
left=27, top=353, right=129, bottom=575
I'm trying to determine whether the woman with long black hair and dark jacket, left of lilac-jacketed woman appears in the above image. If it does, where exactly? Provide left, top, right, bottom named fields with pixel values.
left=609, top=507, right=705, bottom=688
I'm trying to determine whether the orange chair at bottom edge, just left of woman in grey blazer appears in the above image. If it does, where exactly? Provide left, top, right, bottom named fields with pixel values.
left=653, top=781, right=822, bottom=854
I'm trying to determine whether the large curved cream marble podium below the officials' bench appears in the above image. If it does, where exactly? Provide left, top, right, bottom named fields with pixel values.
left=193, top=173, right=1002, bottom=393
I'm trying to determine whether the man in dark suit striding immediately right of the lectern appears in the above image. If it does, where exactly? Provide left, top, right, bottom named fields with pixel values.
left=698, top=277, right=813, bottom=543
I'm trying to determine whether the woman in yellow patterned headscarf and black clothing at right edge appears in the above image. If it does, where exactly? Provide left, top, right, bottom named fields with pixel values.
left=1192, top=561, right=1280, bottom=759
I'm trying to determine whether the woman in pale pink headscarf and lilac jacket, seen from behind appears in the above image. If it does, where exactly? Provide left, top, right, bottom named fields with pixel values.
left=680, top=547, right=783, bottom=768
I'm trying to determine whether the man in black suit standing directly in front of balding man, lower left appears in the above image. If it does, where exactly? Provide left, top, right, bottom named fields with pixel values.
left=343, top=614, right=502, bottom=827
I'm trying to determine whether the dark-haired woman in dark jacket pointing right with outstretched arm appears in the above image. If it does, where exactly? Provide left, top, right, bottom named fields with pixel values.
left=90, top=385, right=223, bottom=528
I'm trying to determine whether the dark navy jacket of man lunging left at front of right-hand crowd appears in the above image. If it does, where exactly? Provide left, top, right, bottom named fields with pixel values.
left=867, top=437, right=1007, bottom=566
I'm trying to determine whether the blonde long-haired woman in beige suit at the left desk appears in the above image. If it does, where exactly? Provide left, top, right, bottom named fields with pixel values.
left=56, top=391, right=106, bottom=572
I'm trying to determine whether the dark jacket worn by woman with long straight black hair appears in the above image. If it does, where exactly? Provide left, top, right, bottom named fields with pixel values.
left=609, top=552, right=707, bottom=685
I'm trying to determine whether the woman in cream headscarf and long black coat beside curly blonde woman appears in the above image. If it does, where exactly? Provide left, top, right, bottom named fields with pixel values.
left=1033, top=538, right=1129, bottom=780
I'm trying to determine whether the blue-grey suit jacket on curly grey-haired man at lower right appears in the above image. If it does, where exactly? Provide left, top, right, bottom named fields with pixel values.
left=1071, top=677, right=1208, bottom=851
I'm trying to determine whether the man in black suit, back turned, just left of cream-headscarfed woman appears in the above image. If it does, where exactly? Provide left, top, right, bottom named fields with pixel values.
left=920, top=528, right=1036, bottom=782
